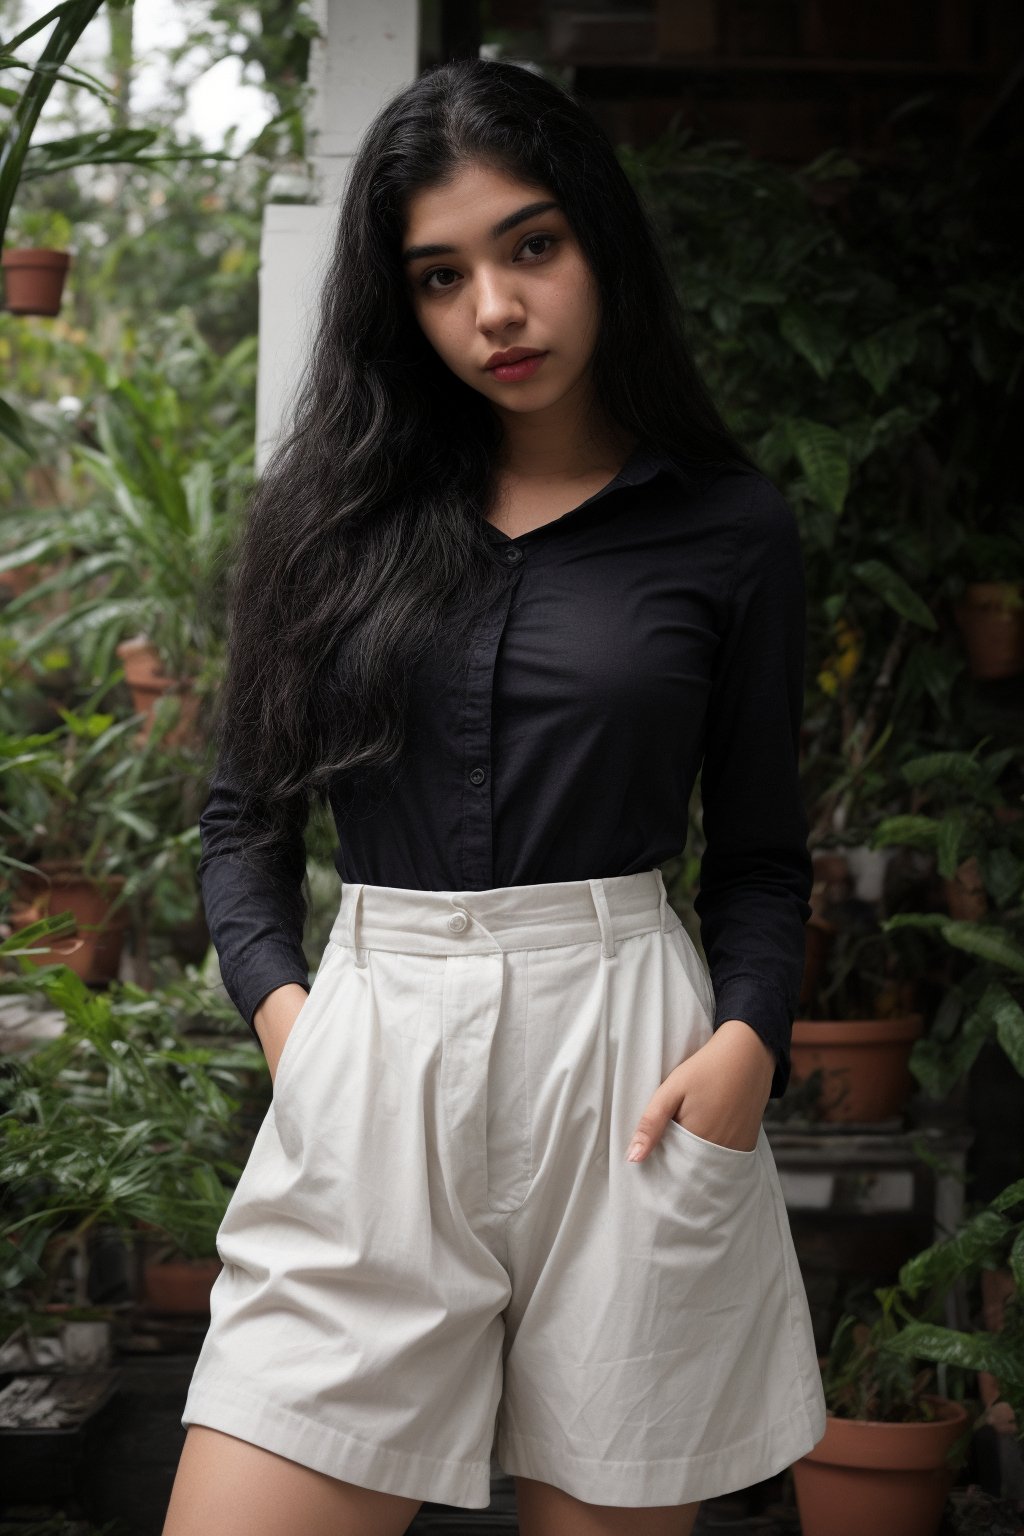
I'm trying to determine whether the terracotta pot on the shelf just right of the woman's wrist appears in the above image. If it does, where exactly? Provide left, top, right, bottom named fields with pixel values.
left=791, top=1014, right=923, bottom=1123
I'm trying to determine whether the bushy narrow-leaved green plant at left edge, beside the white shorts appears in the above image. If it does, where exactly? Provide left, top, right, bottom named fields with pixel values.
left=0, top=966, right=251, bottom=1310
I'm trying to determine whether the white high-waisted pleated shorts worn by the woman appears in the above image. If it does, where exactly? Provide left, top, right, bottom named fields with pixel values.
left=181, top=869, right=824, bottom=1508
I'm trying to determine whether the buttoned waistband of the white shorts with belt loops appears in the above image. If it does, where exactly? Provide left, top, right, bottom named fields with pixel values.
left=330, top=869, right=680, bottom=966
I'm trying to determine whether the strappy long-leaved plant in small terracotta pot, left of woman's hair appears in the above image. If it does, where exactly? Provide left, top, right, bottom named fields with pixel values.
left=5, top=327, right=245, bottom=746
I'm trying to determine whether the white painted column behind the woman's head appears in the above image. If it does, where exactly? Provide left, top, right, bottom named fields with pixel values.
left=256, top=0, right=419, bottom=470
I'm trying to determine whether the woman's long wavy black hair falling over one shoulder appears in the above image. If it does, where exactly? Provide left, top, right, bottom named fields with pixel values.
left=215, top=58, right=752, bottom=851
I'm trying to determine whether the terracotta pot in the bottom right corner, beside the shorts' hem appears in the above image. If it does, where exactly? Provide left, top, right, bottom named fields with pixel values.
left=792, top=1393, right=967, bottom=1536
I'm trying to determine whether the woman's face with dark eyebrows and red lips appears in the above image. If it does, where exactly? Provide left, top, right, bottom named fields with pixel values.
left=402, top=164, right=599, bottom=412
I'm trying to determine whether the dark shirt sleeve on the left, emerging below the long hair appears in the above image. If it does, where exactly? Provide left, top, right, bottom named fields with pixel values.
left=197, top=760, right=310, bottom=1044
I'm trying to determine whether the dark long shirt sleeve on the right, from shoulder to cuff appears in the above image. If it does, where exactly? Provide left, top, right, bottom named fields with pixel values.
left=694, top=478, right=814, bottom=1098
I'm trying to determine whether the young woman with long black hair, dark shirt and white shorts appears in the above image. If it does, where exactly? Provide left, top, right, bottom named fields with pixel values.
left=166, top=61, right=824, bottom=1536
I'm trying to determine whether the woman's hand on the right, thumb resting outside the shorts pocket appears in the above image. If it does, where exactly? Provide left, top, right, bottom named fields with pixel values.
left=626, top=1018, right=775, bottom=1163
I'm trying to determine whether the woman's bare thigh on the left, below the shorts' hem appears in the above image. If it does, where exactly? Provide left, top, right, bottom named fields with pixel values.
left=163, top=1424, right=422, bottom=1536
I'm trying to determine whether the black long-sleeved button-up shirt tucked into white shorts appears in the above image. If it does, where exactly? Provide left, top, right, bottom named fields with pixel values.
left=200, top=445, right=812, bottom=1098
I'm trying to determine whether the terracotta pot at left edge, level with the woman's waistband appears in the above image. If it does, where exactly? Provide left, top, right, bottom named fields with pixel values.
left=9, top=859, right=127, bottom=983
